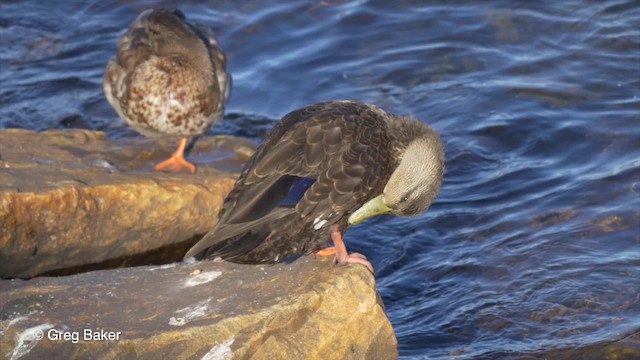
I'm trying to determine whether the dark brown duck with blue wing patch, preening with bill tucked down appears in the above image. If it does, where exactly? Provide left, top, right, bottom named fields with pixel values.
left=185, top=101, right=444, bottom=272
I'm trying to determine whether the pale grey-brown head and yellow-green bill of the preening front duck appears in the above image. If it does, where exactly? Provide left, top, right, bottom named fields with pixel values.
left=349, top=128, right=444, bottom=225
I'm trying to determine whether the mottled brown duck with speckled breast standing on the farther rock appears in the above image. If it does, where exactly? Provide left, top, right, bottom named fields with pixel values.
left=103, top=9, right=231, bottom=173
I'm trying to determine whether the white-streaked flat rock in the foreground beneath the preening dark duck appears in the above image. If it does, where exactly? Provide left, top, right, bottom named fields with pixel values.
left=0, top=256, right=398, bottom=359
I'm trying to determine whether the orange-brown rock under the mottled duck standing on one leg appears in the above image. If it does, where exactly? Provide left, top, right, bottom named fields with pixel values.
left=0, top=129, right=254, bottom=278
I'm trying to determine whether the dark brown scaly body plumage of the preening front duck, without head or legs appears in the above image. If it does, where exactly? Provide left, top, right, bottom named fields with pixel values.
left=190, top=101, right=440, bottom=263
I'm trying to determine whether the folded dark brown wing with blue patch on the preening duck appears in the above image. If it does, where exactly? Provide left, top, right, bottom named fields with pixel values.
left=185, top=103, right=390, bottom=258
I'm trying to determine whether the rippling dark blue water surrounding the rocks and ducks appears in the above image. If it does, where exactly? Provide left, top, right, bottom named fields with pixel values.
left=0, top=0, right=640, bottom=359
